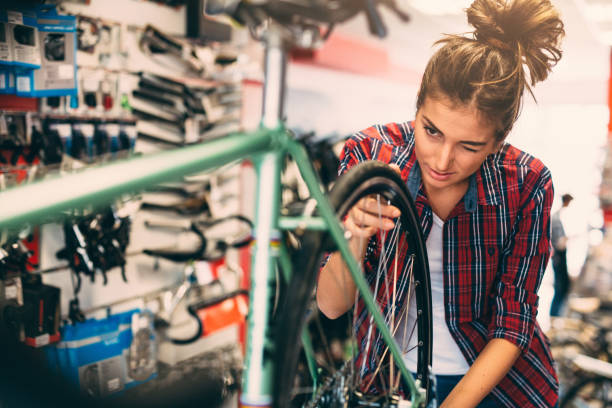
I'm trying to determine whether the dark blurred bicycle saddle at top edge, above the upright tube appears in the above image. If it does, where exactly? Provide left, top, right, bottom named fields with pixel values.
left=205, top=0, right=410, bottom=38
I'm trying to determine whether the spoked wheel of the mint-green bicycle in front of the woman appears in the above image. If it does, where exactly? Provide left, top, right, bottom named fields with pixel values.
left=274, top=161, right=432, bottom=407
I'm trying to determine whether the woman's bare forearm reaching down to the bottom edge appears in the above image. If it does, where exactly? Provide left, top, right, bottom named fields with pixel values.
left=440, top=339, right=521, bottom=408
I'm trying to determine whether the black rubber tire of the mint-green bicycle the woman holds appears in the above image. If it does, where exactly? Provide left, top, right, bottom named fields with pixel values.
left=274, top=161, right=432, bottom=407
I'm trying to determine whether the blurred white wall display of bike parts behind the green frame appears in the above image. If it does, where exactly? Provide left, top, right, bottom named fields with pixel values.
left=0, top=0, right=251, bottom=404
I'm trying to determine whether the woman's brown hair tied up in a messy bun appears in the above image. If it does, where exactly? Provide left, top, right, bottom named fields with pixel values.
left=417, top=0, right=565, bottom=140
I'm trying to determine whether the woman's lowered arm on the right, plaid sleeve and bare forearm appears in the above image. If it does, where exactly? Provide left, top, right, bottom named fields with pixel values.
left=441, top=170, right=553, bottom=408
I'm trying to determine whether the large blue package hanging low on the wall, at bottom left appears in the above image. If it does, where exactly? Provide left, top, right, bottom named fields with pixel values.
left=46, top=309, right=157, bottom=397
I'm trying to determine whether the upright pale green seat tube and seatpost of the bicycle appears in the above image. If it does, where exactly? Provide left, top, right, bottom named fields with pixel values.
left=240, top=24, right=287, bottom=407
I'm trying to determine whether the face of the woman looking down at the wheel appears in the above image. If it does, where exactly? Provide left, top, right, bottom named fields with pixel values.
left=414, top=97, right=501, bottom=193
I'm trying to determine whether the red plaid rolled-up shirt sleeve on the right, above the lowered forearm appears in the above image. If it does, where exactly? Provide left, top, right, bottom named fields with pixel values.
left=489, top=168, right=554, bottom=350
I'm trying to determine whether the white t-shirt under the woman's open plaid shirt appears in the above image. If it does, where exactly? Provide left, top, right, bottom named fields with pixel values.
left=395, top=213, right=470, bottom=375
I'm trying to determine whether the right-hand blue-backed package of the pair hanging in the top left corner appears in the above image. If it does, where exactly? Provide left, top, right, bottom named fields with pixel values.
left=16, top=5, right=77, bottom=97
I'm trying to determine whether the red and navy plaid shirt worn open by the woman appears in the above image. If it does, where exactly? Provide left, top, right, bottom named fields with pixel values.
left=339, top=122, right=558, bottom=408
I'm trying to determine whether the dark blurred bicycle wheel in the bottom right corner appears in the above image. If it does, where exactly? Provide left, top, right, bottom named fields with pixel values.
left=560, top=377, right=612, bottom=408
